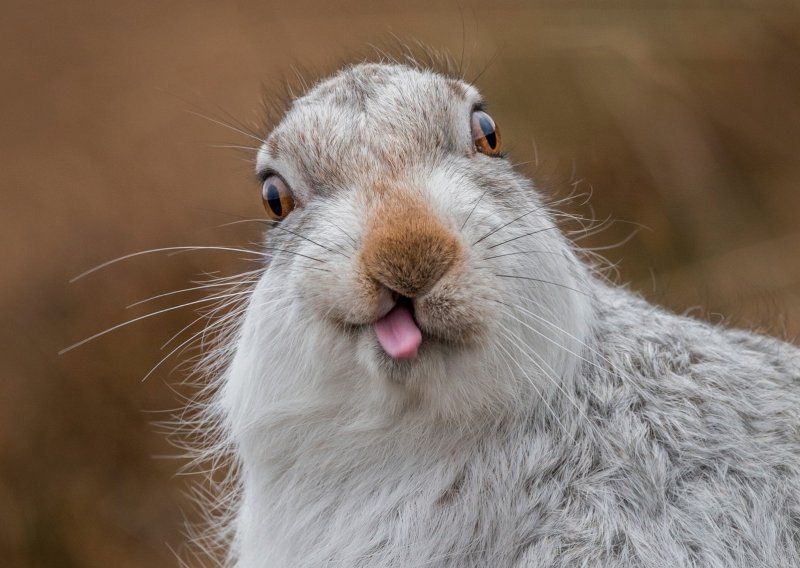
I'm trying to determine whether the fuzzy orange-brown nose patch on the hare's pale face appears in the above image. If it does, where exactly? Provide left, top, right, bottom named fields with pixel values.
left=361, top=207, right=461, bottom=298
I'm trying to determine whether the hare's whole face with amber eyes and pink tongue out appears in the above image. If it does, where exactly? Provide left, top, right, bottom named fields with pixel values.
left=232, top=64, right=586, bottom=422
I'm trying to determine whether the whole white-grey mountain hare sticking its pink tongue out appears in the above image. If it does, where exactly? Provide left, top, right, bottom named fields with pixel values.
left=210, top=64, right=800, bottom=568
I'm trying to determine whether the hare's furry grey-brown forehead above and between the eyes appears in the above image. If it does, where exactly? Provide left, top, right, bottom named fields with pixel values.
left=258, top=64, right=480, bottom=189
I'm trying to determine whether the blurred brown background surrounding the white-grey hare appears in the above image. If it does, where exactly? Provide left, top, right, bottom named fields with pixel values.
left=0, top=0, right=800, bottom=567
